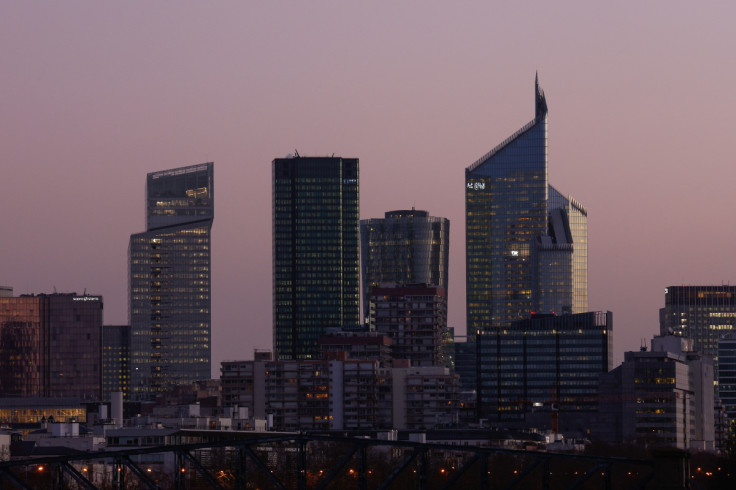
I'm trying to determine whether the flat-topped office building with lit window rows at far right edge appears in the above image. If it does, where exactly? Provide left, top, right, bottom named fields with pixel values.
left=659, top=286, right=736, bottom=372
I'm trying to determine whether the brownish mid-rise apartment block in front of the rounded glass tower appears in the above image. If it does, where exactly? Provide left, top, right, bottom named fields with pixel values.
left=369, top=284, right=450, bottom=367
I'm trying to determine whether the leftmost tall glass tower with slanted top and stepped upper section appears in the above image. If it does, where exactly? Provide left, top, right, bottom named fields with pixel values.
left=128, top=163, right=214, bottom=399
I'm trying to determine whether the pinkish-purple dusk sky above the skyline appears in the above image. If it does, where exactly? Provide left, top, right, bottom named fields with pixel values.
left=0, top=1, right=736, bottom=377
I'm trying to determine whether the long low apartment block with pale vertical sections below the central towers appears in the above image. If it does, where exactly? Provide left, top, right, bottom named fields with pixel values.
left=221, top=356, right=457, bottom=431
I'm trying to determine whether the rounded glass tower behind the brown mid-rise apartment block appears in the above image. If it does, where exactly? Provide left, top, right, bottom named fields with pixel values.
left=360, top=209, right=450, bottom=318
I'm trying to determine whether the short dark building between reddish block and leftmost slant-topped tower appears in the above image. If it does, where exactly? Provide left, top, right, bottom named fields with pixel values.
left=102, top=325, right=130, bottom=401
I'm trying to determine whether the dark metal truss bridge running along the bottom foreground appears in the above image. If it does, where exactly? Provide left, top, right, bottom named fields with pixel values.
left=0, top=433, right=688, bottom=490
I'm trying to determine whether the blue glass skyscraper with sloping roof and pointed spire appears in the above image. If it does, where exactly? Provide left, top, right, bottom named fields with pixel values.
left=465, top=75, right=588, bottom=332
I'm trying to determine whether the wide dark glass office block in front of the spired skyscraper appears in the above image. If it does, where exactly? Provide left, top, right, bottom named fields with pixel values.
left=478, top=311, right=613, bottom=427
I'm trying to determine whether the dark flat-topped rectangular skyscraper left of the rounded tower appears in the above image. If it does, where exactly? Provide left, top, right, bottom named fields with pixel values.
left=272, top=155, right=360, bottom=359
